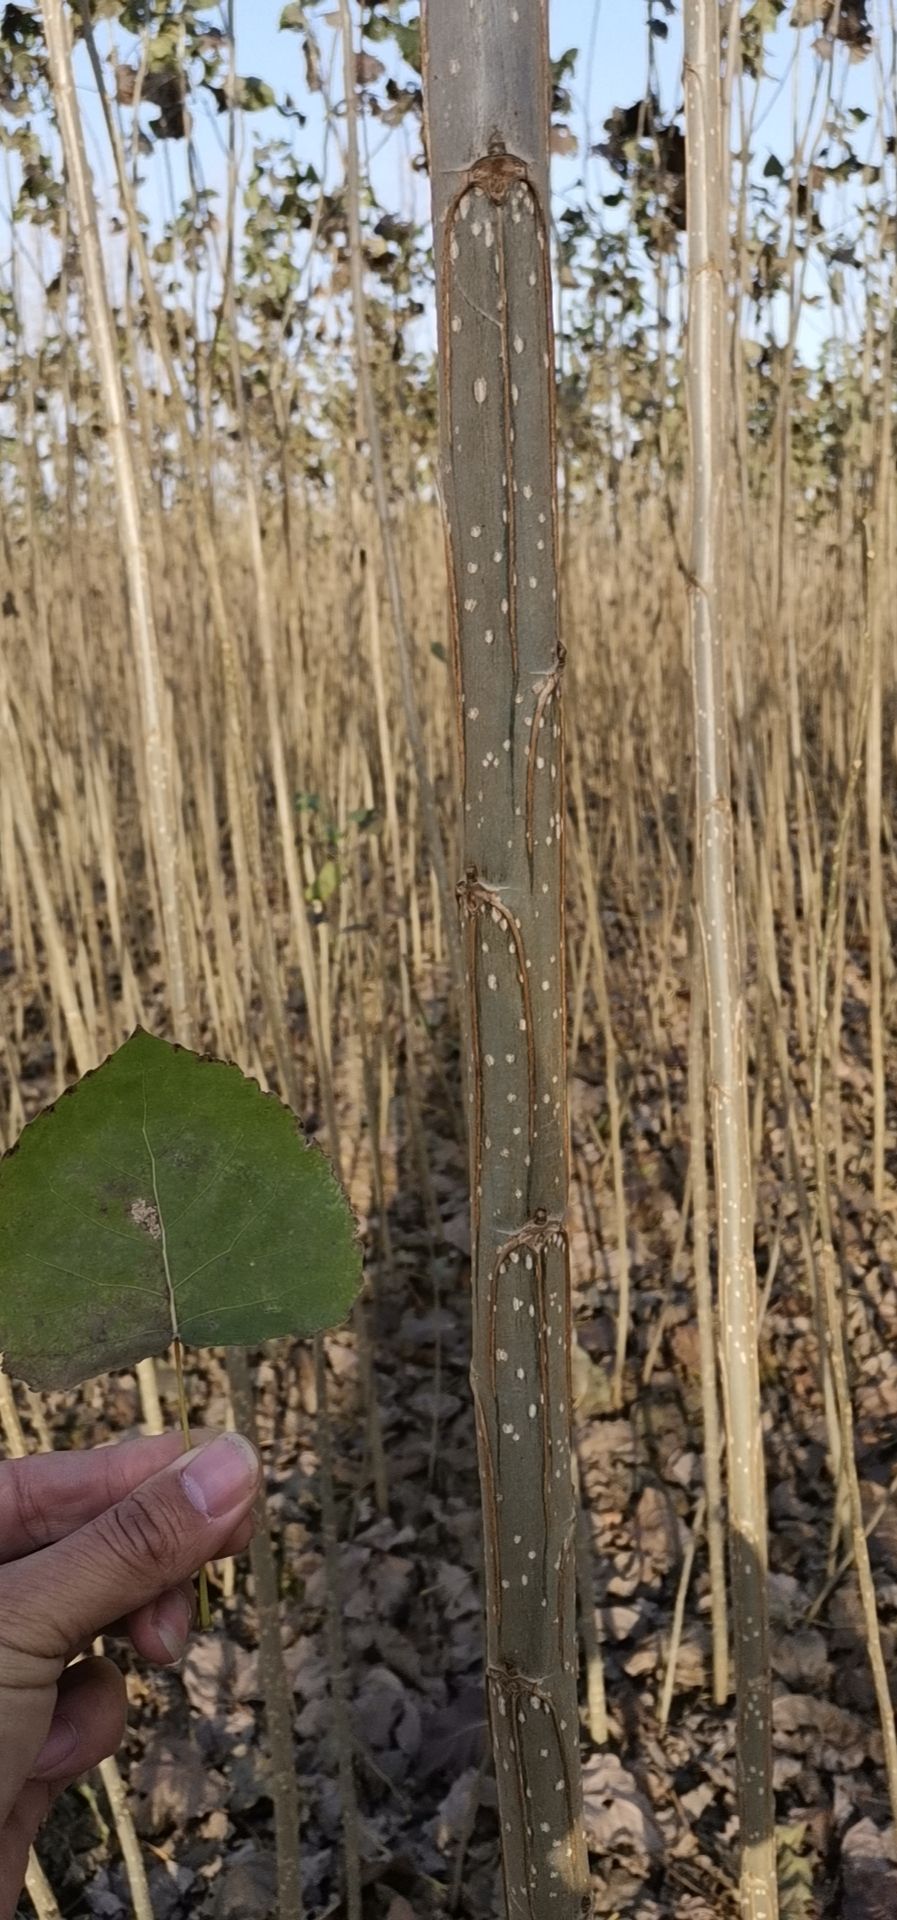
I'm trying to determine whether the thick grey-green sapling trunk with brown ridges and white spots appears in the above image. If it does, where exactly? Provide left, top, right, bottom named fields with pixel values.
left=423, top=0, right=590, bottom=1920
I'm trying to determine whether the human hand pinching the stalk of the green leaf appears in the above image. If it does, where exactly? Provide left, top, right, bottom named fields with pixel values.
left=0, top=1432, right=261, bottom=1920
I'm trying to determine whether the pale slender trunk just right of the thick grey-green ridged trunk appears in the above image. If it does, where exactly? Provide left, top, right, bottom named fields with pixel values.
left=684, top=0, right=778, bottom=1920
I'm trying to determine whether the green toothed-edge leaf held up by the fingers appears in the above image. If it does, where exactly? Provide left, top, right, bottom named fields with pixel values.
left=0, top=1027, right=361, bottom=1388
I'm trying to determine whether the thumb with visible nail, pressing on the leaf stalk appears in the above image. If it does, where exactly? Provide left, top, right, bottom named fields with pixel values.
left=0, top=1434, right=261, bottom=1804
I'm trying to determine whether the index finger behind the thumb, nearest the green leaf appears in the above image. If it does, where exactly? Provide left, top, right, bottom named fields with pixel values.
left=0, top=1428, right=215, bottom=1565
